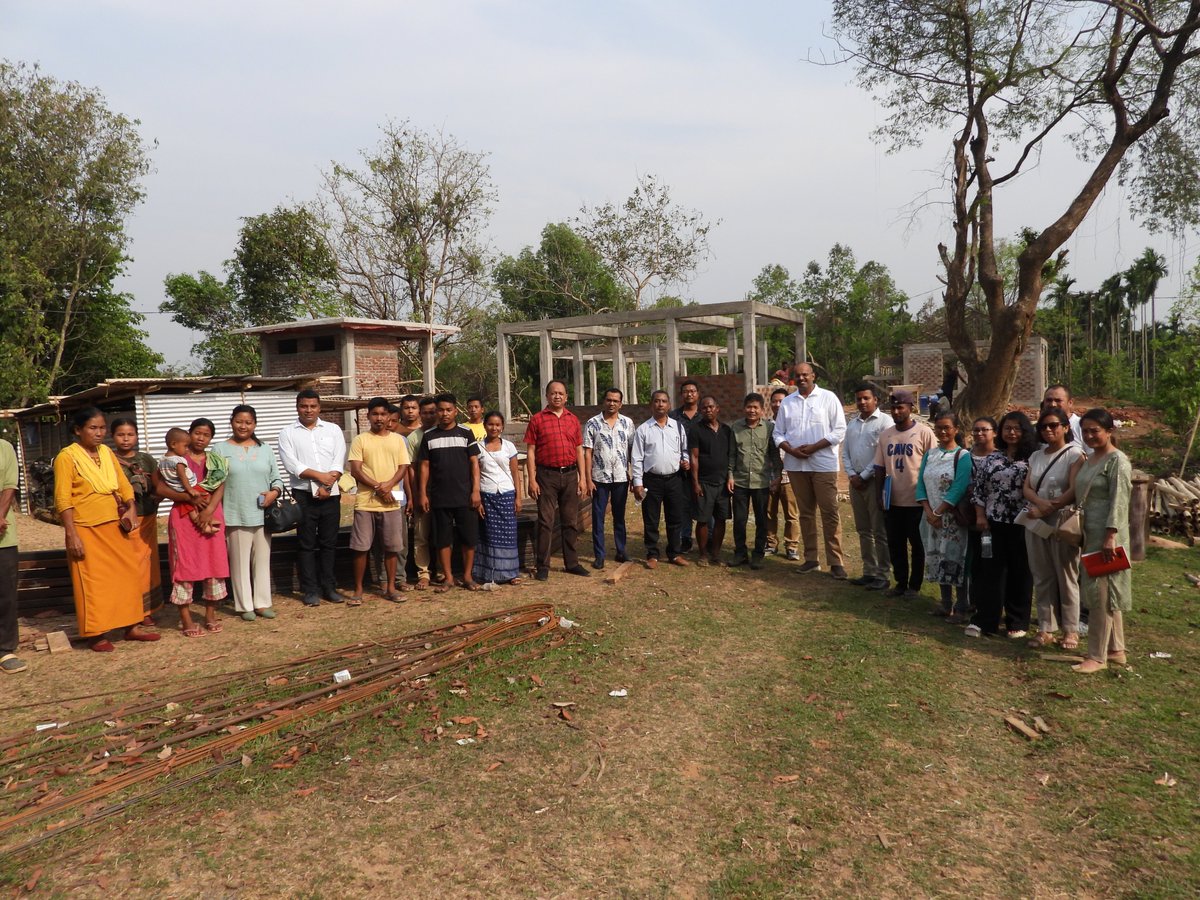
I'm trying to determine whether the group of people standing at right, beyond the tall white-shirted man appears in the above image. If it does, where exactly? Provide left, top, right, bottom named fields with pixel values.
left=846, top=384, right=1132, bottom=672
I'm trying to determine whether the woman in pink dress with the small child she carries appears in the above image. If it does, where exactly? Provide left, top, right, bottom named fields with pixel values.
left=157, top=419, right=229, bottom=637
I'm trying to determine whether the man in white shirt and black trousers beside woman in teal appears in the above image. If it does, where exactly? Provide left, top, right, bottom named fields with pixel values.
left=273, top=388, right=346, bottom=606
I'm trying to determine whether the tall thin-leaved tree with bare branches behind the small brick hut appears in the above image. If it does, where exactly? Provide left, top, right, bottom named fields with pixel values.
left=320, top=122, right=497, bottom=336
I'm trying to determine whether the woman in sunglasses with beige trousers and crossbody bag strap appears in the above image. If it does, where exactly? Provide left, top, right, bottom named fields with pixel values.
left=1022, top=409, right=1087, bottom=650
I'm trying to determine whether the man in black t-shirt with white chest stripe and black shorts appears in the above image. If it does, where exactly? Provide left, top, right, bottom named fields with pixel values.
left=419, top=394, right=482, bottom=594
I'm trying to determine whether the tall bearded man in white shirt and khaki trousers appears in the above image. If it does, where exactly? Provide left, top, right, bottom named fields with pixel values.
left=775, top=362, right=846, bottom=578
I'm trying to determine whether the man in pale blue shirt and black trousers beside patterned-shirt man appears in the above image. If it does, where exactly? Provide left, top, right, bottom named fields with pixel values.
left=630, top=391, right=691, bottom=569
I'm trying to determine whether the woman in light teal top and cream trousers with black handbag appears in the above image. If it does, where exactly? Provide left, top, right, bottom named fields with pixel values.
left=216, top=403, right=283, bottom=622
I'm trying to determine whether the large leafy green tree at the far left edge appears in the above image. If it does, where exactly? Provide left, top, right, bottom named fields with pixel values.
left=0, top=62, right=156, bottom=406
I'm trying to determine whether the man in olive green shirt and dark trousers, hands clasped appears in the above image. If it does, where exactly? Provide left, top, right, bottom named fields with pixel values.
left=728, top=394, right=781, bottom=569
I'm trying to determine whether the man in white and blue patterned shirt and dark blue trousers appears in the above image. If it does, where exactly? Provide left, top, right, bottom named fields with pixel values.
left=583, top=388, right=634, bottom=569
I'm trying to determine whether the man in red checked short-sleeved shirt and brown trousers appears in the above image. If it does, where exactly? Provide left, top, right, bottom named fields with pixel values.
left=526, top=382, right=590, bottom=581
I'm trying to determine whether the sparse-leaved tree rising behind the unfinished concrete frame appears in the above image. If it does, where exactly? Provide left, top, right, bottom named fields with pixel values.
left=574, top=175, right=720, bottom=308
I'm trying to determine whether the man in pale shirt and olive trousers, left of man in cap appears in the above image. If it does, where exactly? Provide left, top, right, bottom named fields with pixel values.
left=841, top=382, right=895, bottom=590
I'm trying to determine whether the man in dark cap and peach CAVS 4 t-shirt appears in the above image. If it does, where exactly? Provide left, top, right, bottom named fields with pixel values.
left=868, top=390, right=937, bottom=599
